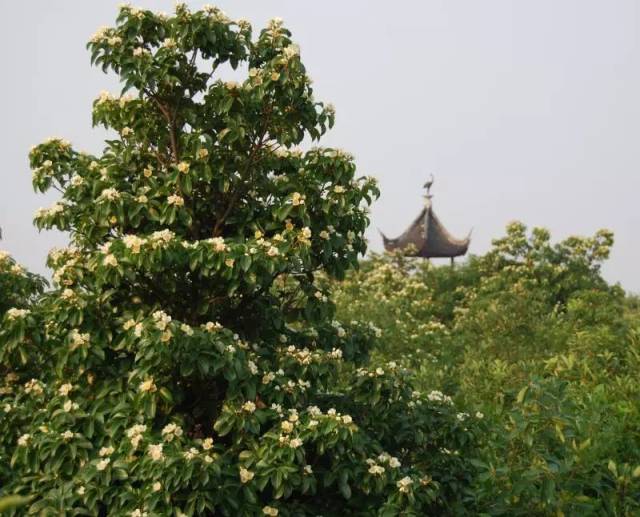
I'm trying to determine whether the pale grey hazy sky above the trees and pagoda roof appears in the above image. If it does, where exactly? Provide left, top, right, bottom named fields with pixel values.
left=0, top=0, right=640, bottom=292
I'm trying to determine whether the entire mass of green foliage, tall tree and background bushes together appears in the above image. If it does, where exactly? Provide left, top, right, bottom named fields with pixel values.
left=0, top=4, right=640, bottom=517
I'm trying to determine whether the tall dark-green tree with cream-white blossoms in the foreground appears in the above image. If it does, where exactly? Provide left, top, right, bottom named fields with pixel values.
left=0, top=5, right=480, bottom=516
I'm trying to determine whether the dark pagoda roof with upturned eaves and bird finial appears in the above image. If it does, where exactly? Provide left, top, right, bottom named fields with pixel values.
left=380, top=176, right=471, bottom=265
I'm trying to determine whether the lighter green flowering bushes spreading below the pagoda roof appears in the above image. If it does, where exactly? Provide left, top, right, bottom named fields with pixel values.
left=333, top=223, right=640, bottom=515
